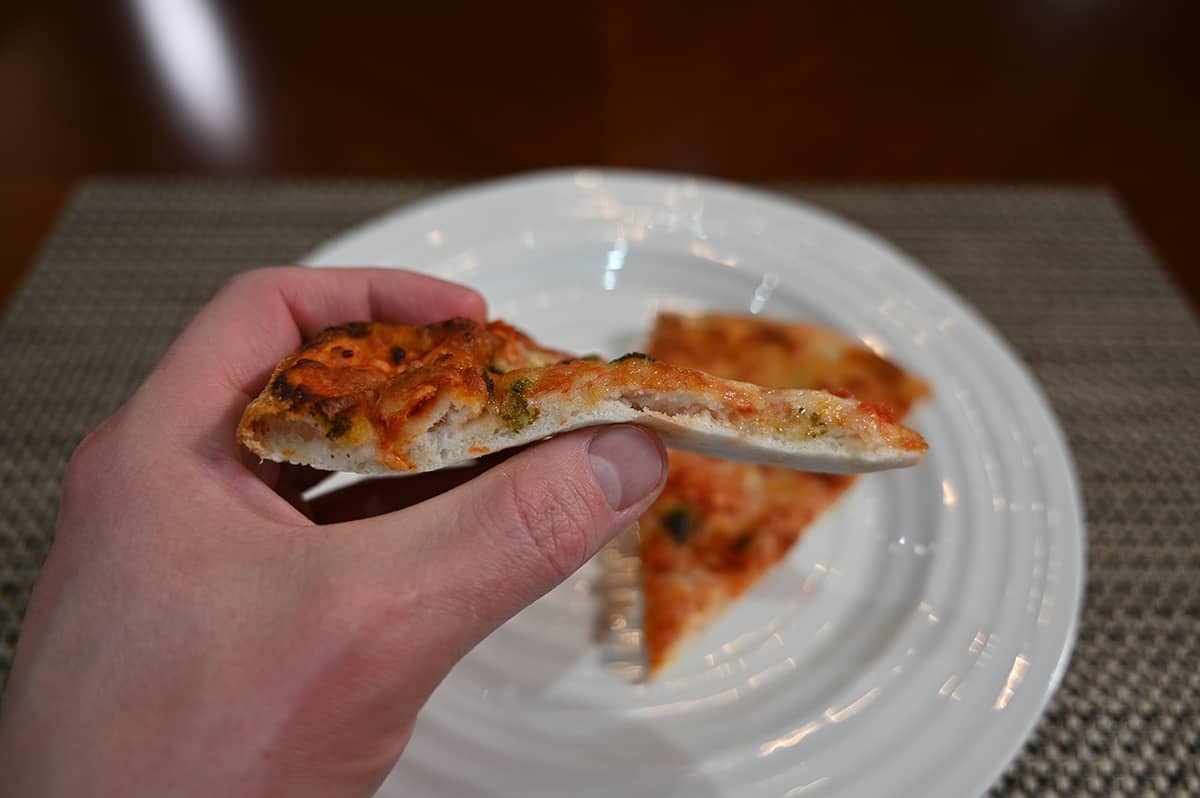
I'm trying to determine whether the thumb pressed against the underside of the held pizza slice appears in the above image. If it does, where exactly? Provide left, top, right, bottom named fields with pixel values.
left=322, top=426, right=666, bottom=690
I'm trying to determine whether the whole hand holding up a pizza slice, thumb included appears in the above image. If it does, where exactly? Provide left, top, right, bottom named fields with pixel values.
left=0, top=268, right=666, bottom=796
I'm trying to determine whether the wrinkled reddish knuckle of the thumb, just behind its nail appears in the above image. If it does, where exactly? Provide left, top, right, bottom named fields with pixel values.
left=509, top=473, right=598, bottom=581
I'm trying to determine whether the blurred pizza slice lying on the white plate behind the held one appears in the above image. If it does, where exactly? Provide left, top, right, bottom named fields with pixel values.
left=638, top=314, right=929, bottom=676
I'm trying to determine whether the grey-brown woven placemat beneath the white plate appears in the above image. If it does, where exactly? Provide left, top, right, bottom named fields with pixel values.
left=0, top=180, right=1200, bottom=796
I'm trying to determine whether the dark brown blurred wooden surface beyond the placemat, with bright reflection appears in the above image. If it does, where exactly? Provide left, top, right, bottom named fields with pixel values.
left=0, top=0, right=1200, bottom=306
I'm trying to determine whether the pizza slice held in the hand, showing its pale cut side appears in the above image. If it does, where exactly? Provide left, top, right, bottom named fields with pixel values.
left=238, top=319, right=925, bottom=473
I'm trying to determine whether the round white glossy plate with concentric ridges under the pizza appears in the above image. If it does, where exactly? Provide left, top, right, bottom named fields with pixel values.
left=310, top=172, right=1084, bottom=798
